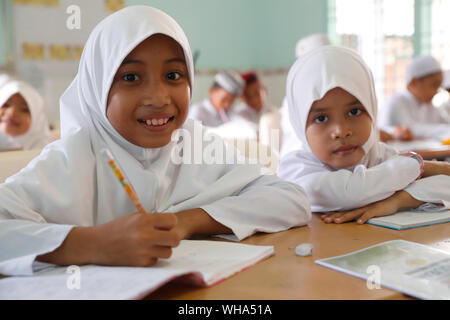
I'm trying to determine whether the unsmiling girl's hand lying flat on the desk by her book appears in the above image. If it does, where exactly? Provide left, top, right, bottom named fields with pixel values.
left=321, top=191, right=424, bottom=224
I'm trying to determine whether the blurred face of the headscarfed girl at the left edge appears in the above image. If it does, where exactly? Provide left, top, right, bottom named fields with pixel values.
left=0, top=93, right=31, bottom=137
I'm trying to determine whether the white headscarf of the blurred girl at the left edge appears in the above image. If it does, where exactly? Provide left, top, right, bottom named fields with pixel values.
left=0, top=78, right=50, bottom=150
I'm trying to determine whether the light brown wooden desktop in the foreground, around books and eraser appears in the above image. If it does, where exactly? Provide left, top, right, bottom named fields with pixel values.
left=147, top=214, right=450, bottom=300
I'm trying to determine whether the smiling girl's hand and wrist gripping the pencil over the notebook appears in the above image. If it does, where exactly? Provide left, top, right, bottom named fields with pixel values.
left=36, top=212, right=181, bottom=267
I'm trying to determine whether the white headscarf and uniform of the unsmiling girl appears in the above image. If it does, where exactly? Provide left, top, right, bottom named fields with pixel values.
left=278, top=46, right=450, bottom=212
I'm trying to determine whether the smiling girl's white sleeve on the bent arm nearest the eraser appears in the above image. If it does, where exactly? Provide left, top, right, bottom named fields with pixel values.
left=201, top=175, right=311, bottom=241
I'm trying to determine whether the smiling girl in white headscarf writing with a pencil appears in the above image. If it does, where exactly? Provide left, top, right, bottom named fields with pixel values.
left=0, top=6, right=310, bottom=275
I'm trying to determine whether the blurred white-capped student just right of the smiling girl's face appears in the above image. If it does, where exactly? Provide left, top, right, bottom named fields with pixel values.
left=188, top=71, right=244, bottom=127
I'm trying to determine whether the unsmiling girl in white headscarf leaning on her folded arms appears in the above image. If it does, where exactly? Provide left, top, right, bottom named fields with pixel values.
left=278, top=46, right=450, bottom=223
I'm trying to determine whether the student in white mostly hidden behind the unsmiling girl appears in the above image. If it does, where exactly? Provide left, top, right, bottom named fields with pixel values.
left=280, top=33, right=331, bottom=157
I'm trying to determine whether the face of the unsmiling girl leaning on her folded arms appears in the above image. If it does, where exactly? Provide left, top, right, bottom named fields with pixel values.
left=306, top=88, right=372, bottom=169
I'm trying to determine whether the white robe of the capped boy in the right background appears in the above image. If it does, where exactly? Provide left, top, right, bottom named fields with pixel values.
left=379, top=89, right=450, bottom=139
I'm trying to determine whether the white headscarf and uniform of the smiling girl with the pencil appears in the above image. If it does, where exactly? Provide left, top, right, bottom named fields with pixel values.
left=0, top=6, right=311, bottom=275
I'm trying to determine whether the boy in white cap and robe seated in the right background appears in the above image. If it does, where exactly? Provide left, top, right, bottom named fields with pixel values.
left=379, top=56, right=450, bottom=138
